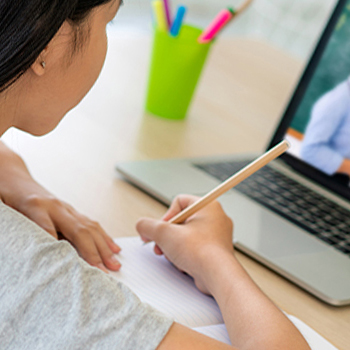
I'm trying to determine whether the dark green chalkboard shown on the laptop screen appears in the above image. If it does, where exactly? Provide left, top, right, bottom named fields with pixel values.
left=291, top=0, right=350, bottom=134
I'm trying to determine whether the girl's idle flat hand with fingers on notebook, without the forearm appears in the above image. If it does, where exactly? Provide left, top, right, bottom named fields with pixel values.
left=6, top=180, right=120, bottom=271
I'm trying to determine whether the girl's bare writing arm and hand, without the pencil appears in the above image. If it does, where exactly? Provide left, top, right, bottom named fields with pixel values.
left=137, top=196, right=310, bottom=350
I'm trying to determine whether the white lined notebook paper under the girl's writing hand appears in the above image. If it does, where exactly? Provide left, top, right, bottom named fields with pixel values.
left=111, top=237, right=336, bottom=350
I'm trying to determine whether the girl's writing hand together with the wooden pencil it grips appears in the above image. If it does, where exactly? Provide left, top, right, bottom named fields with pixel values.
left=137, top=141, right=289, bottom=284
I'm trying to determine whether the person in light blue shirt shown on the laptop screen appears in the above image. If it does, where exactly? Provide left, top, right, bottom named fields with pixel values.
left=301, top=78, right=350, bottom=184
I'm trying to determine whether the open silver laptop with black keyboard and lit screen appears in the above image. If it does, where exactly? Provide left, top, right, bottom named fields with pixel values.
left=117, top=0, right=350, bottom=306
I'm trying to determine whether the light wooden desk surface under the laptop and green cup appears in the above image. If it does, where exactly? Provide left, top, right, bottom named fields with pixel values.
left=4, top=33, right=350, bottom=350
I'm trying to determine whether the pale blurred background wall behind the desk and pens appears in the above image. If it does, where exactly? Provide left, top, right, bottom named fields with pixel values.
left=110, top=0, right=336, bottom=60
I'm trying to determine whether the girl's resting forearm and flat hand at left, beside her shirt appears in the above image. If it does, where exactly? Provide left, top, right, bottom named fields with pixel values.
left=0, top=142, right=120, bottom=272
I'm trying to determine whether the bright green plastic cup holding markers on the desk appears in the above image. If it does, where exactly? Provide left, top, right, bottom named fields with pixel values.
left=146, top=25, right=212, bottom=120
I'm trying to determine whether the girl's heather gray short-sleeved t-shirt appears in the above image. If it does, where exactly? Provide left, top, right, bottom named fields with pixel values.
left=0, top=201, right=172, bottom=350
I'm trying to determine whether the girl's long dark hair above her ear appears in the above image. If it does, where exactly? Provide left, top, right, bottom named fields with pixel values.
left=0, top=0, right=111, bottom=92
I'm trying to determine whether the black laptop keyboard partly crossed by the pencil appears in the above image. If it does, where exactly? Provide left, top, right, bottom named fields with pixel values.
left=194, top=161, right=350, bottom=257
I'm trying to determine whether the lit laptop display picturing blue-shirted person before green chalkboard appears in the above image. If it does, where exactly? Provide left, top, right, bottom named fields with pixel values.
left=286, top=2, right=350, bottom=186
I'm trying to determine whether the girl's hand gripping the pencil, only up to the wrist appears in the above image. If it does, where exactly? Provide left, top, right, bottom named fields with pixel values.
left=137, top=195, right=233, bottom=294
